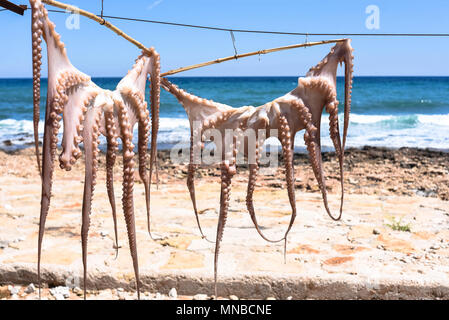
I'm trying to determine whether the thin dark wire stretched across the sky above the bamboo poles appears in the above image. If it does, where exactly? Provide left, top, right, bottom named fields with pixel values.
left=0, top=5, right=449, bottom=37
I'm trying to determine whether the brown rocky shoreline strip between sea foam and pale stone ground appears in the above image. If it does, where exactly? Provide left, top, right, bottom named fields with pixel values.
left=0, top=146, right=449, bottom=200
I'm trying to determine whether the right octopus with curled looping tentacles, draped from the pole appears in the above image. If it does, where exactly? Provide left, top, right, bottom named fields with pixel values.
left=161, top=39, right=353, bottom=296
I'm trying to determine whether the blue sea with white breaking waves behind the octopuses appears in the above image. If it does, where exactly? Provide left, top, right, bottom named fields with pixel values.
left=0, top=76, right=449, bottom=152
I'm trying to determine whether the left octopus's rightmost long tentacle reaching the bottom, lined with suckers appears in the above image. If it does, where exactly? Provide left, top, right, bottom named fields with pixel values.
left=118, top=101, right=140, bottom=299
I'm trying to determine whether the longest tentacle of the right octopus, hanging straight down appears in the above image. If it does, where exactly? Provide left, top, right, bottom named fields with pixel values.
left=214, top=159, right=236, bottom=298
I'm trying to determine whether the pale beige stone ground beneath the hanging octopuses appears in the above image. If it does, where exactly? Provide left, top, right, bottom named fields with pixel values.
left=0, top=149, right=449, bottom=299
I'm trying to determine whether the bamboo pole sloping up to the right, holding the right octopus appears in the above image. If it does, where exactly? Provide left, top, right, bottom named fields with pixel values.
left=161, top=39, right=345, bottom=77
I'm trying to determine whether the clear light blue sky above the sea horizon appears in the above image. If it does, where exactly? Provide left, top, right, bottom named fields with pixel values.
left=0, top=0, right=449, bottom=78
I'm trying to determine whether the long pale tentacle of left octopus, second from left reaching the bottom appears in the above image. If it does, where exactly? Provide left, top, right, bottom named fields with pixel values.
left=81, top=108, right=100, bottom=299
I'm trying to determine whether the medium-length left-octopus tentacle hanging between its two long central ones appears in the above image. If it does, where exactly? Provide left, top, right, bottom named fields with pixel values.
left=104, top=111, right=119, bottom=258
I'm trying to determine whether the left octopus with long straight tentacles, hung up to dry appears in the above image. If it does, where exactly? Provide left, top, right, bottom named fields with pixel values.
left=30, top=0, right=160, bottom=298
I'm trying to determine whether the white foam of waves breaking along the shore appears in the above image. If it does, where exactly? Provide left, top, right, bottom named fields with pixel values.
left=0, top=113, right=449, bottom=149
